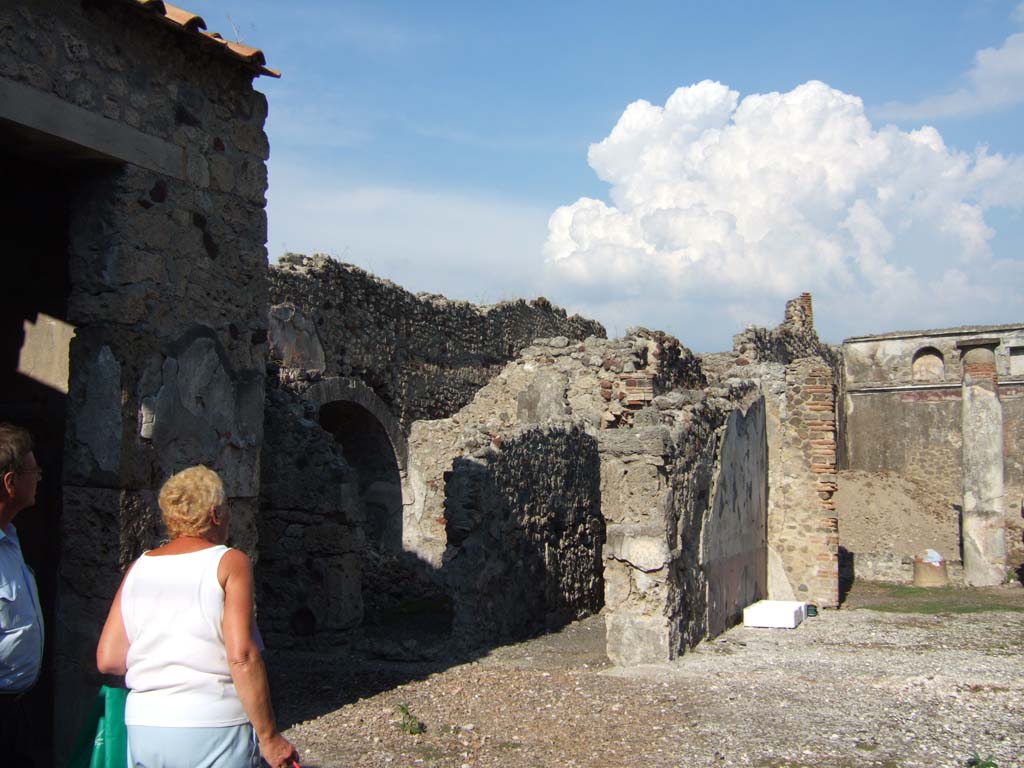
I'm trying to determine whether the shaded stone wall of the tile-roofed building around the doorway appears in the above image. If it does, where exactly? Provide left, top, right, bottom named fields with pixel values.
left=0, top=0, right=268, bottom=754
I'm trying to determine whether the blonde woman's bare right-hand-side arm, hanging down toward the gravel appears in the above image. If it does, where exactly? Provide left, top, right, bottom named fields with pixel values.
left=217, top=549, right=298, bottom=768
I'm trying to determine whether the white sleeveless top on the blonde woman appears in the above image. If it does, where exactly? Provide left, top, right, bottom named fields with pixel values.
left=121, top=546, right=249, bottom=728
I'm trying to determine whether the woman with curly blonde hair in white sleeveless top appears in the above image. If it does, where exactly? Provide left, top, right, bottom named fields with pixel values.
left=96, top=466, right=298, bottom=768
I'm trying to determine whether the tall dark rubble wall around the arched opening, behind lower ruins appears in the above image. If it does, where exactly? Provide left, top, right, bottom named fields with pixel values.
left=257, top=264, right=604, bottom=645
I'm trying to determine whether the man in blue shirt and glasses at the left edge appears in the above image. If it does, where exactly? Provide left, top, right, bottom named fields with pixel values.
left=0, top=423, right=43, bottom=765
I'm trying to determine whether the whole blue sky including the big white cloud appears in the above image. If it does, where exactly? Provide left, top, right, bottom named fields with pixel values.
left=188, top=0, right=1024, bottom=351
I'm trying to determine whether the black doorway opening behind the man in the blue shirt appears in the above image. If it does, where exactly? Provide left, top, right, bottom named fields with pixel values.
left=0, top=126, right=84, bottom=765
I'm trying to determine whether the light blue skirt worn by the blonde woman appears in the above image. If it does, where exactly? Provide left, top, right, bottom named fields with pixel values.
left=128, top=723, right=260, bottom=768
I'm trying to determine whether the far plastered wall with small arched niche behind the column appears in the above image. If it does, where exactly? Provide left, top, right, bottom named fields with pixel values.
left=840, top=327, right=1024, bottom=581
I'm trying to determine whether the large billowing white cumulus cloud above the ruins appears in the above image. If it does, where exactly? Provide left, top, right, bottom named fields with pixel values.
left=544, top=81, right=1024, bottom=348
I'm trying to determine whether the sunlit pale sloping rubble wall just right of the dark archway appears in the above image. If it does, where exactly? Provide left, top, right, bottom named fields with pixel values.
left=403, top=329, right=703, bottom=566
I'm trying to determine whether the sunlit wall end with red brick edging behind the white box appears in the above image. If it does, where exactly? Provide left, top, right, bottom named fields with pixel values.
left=768, top=357, right=839, bottom=607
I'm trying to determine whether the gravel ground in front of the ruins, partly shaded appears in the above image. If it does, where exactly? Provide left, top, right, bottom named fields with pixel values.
left=269, top=585, right=1024, bottom=768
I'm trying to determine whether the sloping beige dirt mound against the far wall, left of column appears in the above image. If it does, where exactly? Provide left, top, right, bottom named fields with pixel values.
left=836, top=470, right=961, bottom=560
